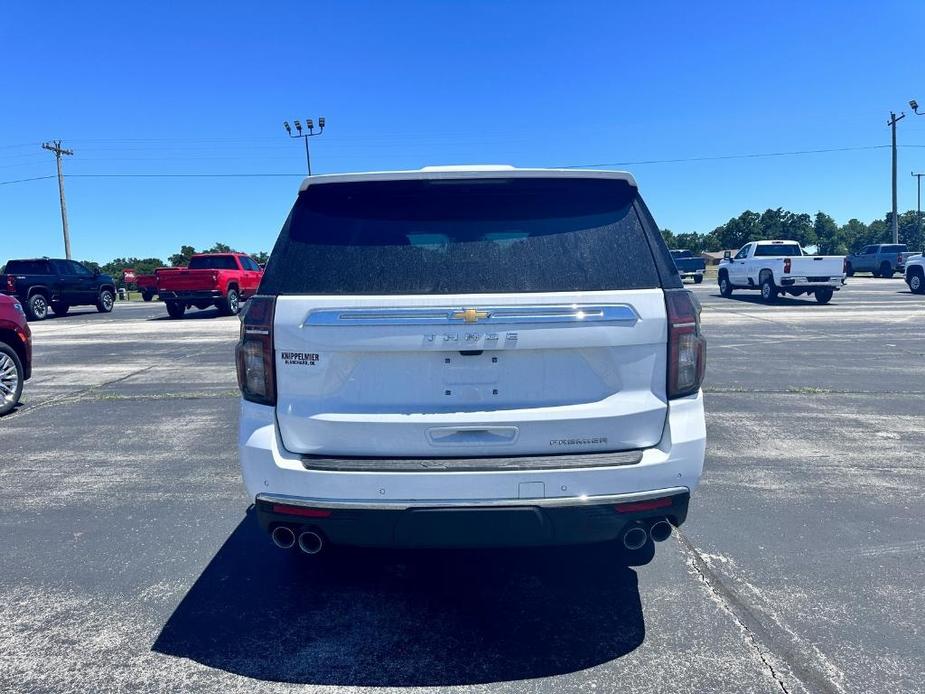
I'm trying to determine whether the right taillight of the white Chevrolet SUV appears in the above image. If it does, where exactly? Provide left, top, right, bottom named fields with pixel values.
left=665, top=289, right=707, bottom=398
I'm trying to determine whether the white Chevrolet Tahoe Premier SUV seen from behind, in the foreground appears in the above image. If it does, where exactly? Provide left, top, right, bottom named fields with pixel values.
left=237, top=167, right=706, bottom=557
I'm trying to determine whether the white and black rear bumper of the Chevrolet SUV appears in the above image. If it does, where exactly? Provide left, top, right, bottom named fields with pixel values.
left=239, top=393, right=706, bottom=546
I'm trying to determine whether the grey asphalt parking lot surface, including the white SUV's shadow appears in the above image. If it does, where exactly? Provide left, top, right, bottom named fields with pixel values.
left=0, top=277, right=925, bottom=693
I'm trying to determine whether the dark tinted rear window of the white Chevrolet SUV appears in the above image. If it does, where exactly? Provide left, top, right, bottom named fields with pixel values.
left=260, top=178, right=660, bottom=294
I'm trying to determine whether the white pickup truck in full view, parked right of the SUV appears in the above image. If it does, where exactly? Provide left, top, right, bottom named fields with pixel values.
left=717, top=241, right=845, bottom=304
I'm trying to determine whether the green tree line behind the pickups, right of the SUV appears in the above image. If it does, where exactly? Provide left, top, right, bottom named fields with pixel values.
left=661, top=207, right=925, bottom=255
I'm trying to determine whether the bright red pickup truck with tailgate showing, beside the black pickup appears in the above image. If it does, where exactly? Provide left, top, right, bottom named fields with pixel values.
left=154, top=253, right=263, bottom=318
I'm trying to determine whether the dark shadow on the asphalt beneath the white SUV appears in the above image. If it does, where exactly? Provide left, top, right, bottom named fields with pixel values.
left=152, top=511, right=645, bottom=687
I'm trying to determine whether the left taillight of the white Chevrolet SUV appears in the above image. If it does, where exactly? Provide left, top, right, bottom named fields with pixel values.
left=235, top=296, right=276, bottom=405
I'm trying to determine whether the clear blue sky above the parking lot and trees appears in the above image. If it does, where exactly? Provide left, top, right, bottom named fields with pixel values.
left=0, top=0, right=925, bottom=262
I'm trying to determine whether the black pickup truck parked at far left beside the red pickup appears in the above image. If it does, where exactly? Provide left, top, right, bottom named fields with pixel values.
left=0, top=258, right=116, bottom=320
